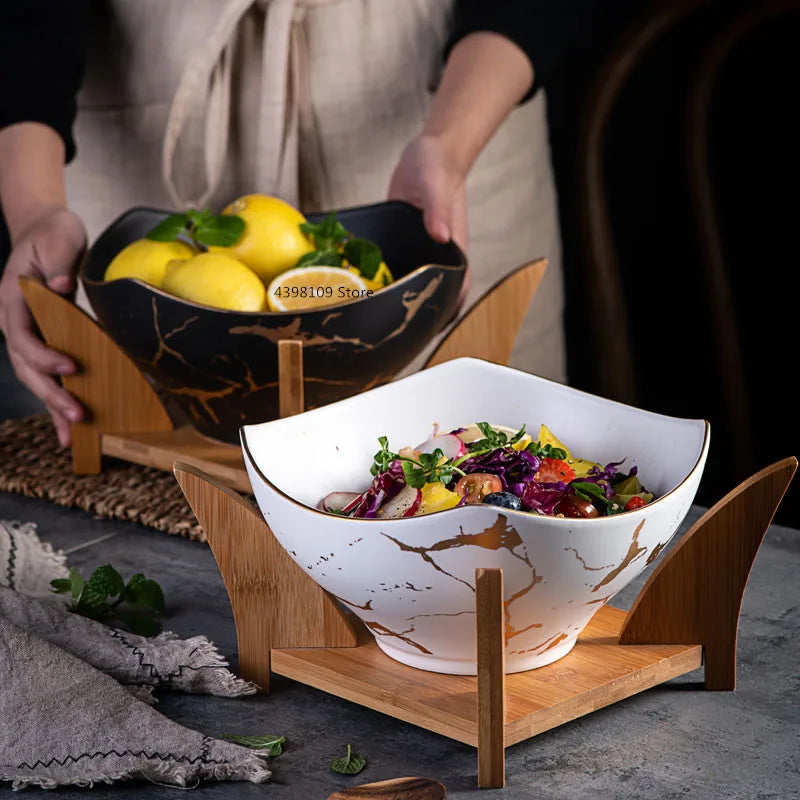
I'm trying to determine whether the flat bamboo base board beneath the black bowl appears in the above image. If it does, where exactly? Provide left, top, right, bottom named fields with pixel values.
left=100, top=425, right=252, bottom=494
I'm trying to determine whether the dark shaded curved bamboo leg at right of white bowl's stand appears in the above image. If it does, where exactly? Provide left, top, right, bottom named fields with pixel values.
left=619, top=458, right=797, bottom=691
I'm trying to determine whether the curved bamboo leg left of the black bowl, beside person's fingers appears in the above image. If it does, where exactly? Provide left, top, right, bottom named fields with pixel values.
left=20, top=278, right=173, bottom=475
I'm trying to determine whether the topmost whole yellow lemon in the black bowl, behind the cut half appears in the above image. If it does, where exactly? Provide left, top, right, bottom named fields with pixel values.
left=209, top=194, right=314, bottom=285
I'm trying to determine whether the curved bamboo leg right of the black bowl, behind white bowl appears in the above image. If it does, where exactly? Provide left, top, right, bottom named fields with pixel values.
left=423, top=258, right=547, bottom=369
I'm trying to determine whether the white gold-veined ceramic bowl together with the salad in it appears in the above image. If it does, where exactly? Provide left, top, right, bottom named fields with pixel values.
left=241, top=358, right=709, bottom=675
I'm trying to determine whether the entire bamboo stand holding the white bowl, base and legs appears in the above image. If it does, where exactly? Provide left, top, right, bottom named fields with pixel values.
left=174, top=458, right=797, bottom=788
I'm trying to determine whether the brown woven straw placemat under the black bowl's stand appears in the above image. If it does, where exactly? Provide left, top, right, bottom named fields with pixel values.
left=0, top=414, right=206, bottom=542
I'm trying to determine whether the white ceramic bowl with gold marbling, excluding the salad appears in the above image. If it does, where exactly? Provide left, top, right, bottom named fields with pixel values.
left=242, top=358, right=709, bottom=675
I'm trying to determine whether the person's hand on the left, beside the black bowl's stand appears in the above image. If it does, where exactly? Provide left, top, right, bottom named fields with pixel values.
left=0, top=205, right=86, bottom=447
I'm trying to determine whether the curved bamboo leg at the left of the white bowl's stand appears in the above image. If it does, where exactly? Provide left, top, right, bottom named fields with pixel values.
left=174, top=462, right=357, bottom=691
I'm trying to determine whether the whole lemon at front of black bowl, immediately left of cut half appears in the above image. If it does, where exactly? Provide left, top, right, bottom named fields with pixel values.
left=162, top=253, right=266, bottom=311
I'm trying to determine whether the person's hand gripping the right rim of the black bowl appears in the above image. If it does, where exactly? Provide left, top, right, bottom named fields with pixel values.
left=389, top=134, right=467, bottom=250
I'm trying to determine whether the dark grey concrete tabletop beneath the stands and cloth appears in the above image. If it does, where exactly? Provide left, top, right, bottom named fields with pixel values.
left=0, top=494, right=800, bottom=800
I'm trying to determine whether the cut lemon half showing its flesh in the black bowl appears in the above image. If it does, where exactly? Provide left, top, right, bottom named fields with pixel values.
left=267, top=267, right=372, bottom=311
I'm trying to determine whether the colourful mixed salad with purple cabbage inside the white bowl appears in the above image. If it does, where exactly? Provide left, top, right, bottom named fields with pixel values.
left=320, top=422, right=653, bottom=520
